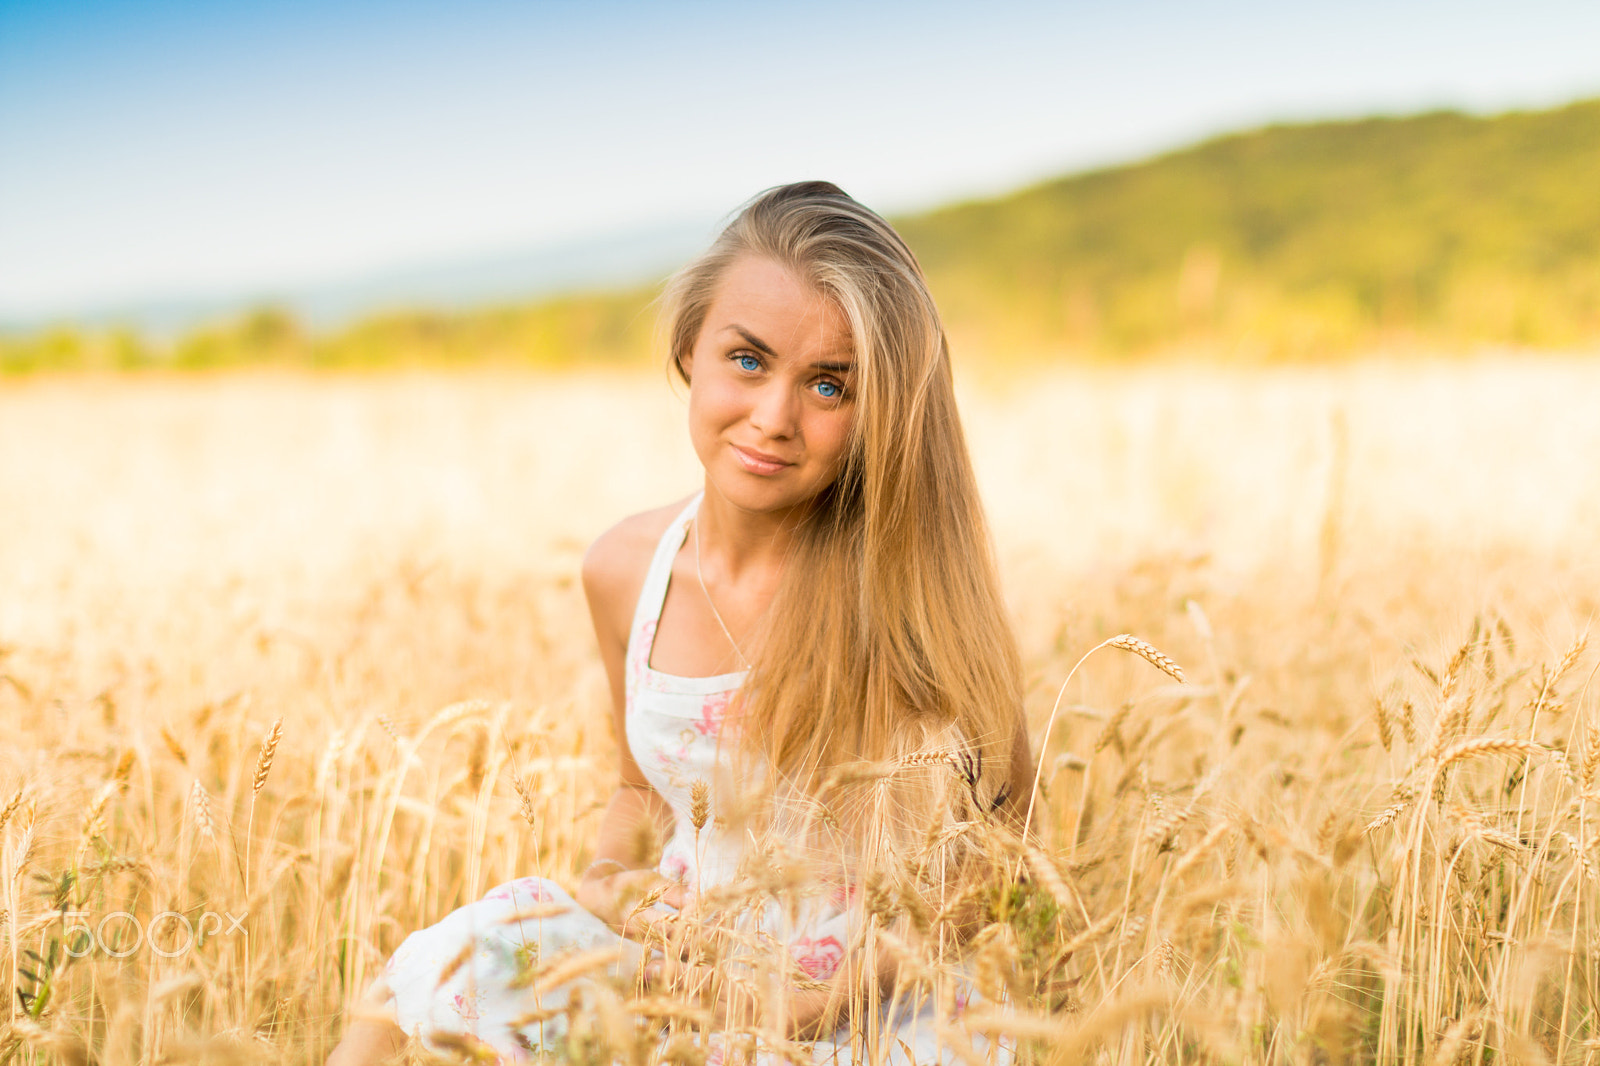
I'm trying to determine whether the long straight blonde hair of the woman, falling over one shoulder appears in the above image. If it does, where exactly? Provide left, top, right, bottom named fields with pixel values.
left=664, top=181, right=1021, bottom=832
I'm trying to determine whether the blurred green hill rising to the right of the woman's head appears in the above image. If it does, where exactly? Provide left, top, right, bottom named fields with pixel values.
left=898, top=101, right=1600, bottom=357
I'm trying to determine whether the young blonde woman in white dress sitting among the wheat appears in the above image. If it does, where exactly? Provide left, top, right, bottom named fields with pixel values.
left=331, top=182, right=1030, bottom=1066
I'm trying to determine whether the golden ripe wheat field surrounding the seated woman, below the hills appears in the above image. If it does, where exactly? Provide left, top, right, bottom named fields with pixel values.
left=0, top=355, right=1600, bottom=1063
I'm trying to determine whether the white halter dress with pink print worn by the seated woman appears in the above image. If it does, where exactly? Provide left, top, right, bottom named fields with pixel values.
left=382, top=496, right=982, bottom=1066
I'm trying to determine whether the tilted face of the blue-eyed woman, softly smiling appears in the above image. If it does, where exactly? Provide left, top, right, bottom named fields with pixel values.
left=683, top=256, right=854, bottom=512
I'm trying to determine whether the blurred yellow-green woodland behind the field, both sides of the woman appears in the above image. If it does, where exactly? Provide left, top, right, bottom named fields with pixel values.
left=0, top=99, right=1600, bottom=373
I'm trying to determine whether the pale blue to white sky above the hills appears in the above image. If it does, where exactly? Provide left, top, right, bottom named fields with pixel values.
left=0, top=0, right=1600, bottom=317
